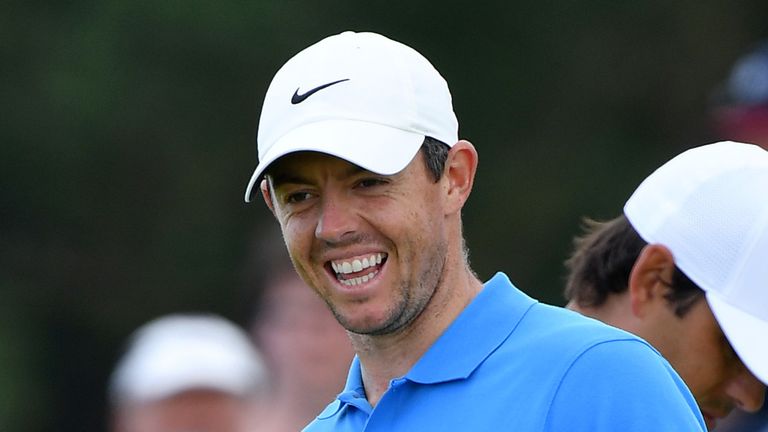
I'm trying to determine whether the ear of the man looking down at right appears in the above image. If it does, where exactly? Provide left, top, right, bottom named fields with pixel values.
left=629, top=243, right=675, bottom=318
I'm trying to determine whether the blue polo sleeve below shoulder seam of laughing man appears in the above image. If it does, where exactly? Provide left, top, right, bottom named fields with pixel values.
left=545, top=340, right=707, bottom=432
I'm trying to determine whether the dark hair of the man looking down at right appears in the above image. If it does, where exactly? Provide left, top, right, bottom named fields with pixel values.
left=565, top=214, right=704, bottom=317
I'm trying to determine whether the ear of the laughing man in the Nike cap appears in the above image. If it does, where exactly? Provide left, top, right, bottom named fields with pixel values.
left=443, top=140, right=477, bottom=213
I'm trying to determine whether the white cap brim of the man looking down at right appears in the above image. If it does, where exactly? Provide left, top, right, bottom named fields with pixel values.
left=707, top=291, right=768, bottom=384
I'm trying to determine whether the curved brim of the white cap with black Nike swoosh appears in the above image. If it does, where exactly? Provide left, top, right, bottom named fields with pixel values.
left=245, top=120, right=425, bottom=202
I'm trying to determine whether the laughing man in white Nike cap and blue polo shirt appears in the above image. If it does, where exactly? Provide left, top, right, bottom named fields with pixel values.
left=246, top=32, right=704, bottom=432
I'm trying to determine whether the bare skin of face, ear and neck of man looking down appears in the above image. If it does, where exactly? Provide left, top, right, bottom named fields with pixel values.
left=568, top=244, right=766, bottom=429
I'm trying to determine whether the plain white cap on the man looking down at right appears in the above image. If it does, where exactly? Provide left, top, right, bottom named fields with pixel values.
left=624, top=141, right=768, bottom=383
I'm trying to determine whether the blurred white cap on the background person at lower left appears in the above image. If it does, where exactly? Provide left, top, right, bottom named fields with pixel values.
left=110, top=314, right=267, bottom=403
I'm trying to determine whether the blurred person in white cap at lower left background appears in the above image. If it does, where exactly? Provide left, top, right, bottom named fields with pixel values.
left=109, top=314, right=266, bottom=432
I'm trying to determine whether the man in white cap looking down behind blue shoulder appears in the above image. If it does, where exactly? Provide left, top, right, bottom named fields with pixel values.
left=565, top=142, right=768, bottom=428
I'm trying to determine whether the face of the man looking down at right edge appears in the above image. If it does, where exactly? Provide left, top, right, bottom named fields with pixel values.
left=647, top=298, right=765, bottom=429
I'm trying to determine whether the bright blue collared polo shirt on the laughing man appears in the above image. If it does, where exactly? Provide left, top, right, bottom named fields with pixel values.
left=304, top=273, right=706, bottom=432
